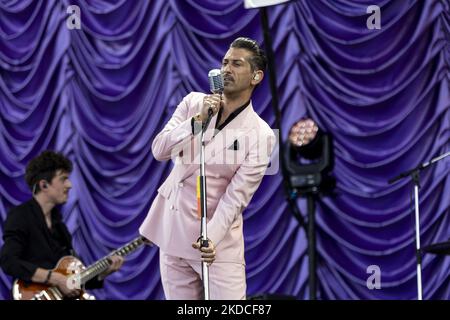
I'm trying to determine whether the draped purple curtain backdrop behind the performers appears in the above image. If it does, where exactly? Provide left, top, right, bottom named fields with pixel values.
left=0, top=0, right=450, bottom=299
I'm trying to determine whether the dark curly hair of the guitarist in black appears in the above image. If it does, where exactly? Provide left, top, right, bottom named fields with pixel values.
left=25, top=151, right=72, bottom=193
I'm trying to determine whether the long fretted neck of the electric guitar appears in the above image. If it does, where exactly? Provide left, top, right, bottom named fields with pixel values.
left=79, top=236, right=146, bottom=285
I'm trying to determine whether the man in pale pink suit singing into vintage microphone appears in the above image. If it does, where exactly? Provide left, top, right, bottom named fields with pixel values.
left=139, top=38, right=275, bottom=299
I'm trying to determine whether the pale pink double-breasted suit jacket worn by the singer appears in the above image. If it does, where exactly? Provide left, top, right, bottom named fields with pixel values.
left=139, top=92, right=275, bottom=264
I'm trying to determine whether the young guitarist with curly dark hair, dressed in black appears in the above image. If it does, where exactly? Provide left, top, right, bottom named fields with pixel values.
left=0, top=151, right=123, bottom=298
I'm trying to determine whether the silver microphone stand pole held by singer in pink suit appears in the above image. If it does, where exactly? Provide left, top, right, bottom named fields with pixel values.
left=197, top=108, right=213, bottom=300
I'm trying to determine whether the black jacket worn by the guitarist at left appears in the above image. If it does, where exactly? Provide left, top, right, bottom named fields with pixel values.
left=0, top=199, right=102, bottom=288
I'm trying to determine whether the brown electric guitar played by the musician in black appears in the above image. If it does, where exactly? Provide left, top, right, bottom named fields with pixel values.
left=12, top=236, right=151, bottom=300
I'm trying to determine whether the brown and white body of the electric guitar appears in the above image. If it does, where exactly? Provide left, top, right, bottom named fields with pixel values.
left=12, top=256, right=95, bottom=300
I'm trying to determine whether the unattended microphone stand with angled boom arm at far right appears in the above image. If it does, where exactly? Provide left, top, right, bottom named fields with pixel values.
left=388, top=152, right=450, bottom=300
